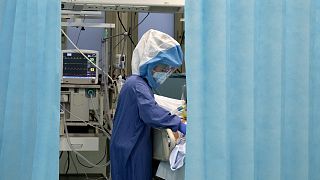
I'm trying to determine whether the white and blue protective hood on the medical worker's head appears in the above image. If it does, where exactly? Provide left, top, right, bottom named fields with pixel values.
left=132, top=29, right=183, bottom=88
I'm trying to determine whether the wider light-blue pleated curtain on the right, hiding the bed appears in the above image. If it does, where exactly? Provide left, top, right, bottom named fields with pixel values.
left=185, top=0, right=320, bottom=180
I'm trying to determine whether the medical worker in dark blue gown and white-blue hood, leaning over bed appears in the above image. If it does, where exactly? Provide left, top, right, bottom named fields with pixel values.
left=110, top=30, right=186, bottom=180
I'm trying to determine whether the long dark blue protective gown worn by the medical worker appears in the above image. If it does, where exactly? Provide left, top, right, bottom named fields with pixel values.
left=110, top=75, right=180, bottom=180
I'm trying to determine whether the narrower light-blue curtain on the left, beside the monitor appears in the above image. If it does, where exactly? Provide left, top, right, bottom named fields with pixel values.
left=0, top=0, right=61, bottom=180
